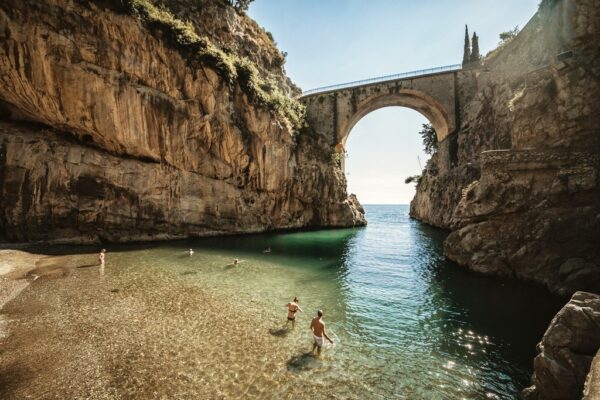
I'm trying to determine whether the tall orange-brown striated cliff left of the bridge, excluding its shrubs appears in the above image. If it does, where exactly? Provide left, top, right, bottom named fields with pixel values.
left=0, top=0, right=365, bottom=242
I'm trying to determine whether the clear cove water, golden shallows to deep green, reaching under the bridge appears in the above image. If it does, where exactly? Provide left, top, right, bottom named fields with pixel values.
left=0, top=206, right=564, bottom=399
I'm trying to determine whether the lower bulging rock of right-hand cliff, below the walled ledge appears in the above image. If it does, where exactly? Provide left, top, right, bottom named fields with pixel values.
left=444, top=150, right=600, bottom=296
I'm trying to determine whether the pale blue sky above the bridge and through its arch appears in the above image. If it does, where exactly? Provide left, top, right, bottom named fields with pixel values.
left=248, top=0, right=539, bottom=204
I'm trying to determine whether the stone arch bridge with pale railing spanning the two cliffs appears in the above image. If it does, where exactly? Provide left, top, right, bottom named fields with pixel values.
left=300, top=64, right=461, bottom=169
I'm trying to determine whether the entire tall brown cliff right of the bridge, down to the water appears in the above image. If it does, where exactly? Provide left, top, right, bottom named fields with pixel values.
left=411, top=0, right=600, bottom=296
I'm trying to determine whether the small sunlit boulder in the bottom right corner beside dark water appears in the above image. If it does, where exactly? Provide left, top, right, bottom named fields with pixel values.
left=523, top=292, right=600, bottom=400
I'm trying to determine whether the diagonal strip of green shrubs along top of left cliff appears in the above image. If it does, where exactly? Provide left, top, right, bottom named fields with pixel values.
left=119, top=0, right=304, bottom=130
